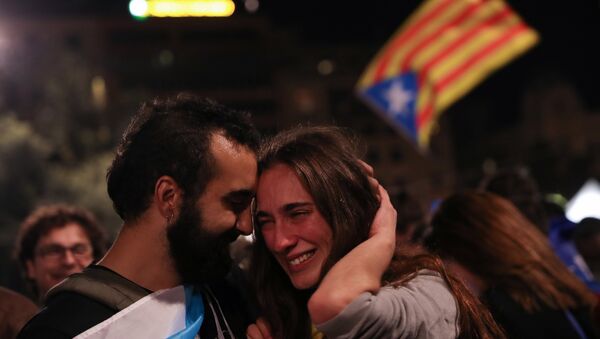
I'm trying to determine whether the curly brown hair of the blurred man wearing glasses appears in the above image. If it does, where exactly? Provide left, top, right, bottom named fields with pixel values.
left=15, top=204, right=109, bottom=272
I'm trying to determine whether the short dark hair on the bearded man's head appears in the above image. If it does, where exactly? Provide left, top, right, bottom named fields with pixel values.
left=106, top=94, right=259, bottom=220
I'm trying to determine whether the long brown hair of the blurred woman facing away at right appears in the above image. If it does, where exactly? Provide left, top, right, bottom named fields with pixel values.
left=427, top=191, right=594, bottom=312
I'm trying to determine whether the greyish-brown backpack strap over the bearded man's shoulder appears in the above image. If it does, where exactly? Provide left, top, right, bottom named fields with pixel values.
left=46, top=268, right=148, bottom=311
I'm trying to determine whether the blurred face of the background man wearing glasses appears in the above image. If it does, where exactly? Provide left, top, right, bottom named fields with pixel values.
left=26, top=223, right=93, bottom=297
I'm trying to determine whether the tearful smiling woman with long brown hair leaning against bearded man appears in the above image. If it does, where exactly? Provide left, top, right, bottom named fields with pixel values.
left=248, top=127, right=503, bottom=338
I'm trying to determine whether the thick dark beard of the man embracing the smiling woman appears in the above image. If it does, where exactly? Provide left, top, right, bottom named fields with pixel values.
left=167, top=198, right=239, bottom=284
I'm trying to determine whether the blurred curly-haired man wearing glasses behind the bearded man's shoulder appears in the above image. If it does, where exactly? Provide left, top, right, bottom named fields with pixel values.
left=15, top=204, right=108, bottom=303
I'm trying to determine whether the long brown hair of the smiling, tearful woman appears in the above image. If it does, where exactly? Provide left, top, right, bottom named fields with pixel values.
left=250, top=127, right=504, bottom=338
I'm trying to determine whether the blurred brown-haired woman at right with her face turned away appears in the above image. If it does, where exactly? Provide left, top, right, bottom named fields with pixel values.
left=426, top=192, right=596, bottom=338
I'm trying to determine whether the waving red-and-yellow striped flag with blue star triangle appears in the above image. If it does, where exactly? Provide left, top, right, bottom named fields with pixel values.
left=356, top=0, right=538, bottom=149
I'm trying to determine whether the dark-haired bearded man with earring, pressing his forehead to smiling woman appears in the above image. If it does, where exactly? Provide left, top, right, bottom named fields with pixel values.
left=20, top=95, right=258, bottom=338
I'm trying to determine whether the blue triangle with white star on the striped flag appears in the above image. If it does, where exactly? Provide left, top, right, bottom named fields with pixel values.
left=362, top=72, right=418, bottom=142
